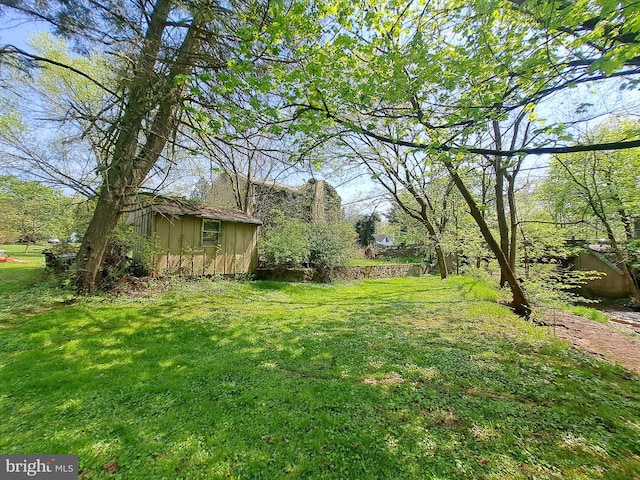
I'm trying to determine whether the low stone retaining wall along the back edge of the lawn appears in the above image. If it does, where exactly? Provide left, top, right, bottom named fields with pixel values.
left=255, top=264, right=429, bottom=283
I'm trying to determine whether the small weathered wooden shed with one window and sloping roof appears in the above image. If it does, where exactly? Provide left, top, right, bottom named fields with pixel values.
left=128, top=197, right=262, bottom=276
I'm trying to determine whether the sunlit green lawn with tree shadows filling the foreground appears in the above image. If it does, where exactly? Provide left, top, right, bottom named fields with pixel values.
left=0, top=247, right=640, bottom=480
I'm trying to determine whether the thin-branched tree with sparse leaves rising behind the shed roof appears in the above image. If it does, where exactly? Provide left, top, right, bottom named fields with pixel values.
left=180, top=71, right=310, bottom=214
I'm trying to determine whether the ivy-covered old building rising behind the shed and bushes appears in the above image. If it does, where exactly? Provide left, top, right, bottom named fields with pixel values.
left=206, top=173, right=342, bottom=226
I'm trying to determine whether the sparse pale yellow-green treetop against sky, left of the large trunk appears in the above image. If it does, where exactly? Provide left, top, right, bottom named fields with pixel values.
left=0, top=33, right=115, bottom=198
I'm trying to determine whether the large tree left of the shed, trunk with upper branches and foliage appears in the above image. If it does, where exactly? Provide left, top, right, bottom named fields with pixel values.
left=2, top=0, right=266, bottom=292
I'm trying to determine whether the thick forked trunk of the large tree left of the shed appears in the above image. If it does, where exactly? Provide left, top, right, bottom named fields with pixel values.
left=77, top=0, right=200, bottom=293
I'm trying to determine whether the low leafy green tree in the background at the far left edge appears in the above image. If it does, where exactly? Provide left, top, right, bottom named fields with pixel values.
left=0, top=176, right=73, bottom=252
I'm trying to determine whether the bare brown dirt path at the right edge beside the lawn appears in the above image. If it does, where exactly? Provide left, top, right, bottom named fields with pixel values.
left=545, top=311, right=640, bottom=374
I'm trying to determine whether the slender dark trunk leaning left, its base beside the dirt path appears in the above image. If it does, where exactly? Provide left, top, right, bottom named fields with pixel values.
left=445, top=162, right=531, bottom=316
